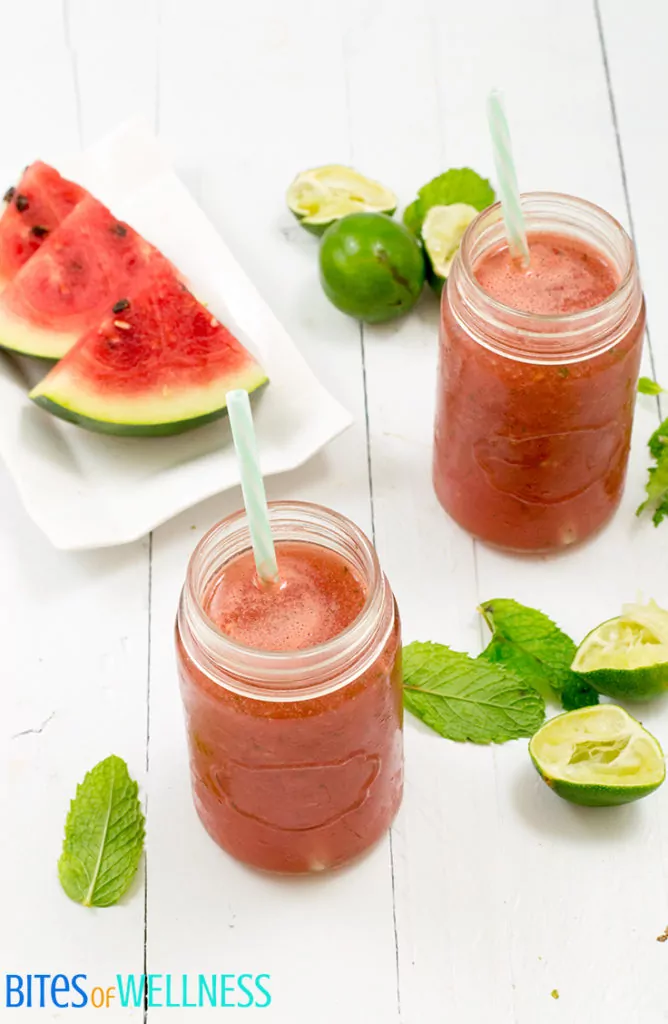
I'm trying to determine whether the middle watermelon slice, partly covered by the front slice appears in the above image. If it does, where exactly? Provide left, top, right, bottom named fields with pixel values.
left=0, top=196, right=163, bottom=359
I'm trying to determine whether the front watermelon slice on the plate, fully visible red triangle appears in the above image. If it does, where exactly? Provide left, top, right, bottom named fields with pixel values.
left=30, top=261, right=266, bottom=436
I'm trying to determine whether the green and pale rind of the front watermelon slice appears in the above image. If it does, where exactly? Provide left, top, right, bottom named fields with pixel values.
left=30, top=362, right=268, bottom=437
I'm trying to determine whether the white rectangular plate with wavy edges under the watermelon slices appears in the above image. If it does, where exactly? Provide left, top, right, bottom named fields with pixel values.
left=0, top=123, right=352, bottom=551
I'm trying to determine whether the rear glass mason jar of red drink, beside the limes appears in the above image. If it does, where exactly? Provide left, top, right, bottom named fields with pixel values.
left=433, top=193, right=644, bottom=552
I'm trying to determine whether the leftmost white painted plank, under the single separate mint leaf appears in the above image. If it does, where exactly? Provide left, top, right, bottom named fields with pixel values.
left=0, top=2, right=148, bottom=1022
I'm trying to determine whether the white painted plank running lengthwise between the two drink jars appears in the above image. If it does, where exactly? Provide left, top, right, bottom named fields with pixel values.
left=340, top=0, right=512, bottom=1022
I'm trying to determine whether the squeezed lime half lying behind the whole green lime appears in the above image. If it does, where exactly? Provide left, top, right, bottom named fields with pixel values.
left=287, top=164, right=396, bottom=234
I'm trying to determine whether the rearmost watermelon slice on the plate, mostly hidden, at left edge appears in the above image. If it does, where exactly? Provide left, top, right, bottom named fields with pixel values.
left=0, top=160, right=88, bottom=292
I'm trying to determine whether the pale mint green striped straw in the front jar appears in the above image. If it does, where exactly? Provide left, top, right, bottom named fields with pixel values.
left=225, top=389, right=279, bottom=583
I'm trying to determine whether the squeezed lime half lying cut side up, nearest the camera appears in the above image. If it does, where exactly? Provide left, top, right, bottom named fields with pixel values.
left=529, top=705, right=666, bottom=807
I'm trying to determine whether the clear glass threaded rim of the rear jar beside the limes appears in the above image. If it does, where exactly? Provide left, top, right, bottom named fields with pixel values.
left=444, top=191, right=641, bottom=362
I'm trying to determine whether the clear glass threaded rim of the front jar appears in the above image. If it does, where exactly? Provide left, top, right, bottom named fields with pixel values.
left=177, top=501, right=391, bottom=700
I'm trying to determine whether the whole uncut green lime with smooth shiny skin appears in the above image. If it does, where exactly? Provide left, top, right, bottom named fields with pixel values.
left=320, top=213, right=424, bottom=324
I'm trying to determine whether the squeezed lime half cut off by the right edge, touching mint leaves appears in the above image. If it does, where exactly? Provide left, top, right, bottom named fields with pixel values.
left=571, top=601, right=668, bottom=700
